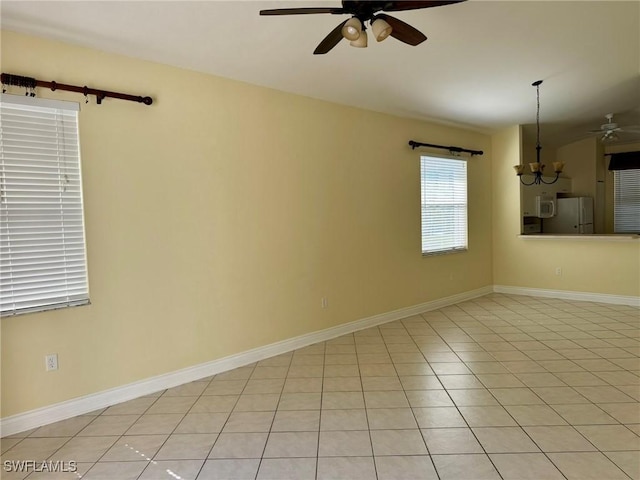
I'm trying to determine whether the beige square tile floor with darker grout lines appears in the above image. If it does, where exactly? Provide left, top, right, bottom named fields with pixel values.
left=2, top=294, right=640, bottom=480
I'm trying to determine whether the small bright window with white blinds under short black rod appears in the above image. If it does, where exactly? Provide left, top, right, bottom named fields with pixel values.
left=420, top=157, right=467, bottom=255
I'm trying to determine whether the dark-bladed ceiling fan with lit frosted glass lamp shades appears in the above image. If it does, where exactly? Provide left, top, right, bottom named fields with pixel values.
left=260, top=0, right=465, bottom=55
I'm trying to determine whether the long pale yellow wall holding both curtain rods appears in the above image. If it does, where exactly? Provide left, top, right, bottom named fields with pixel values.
left=1, top=32, right=496, bottom=417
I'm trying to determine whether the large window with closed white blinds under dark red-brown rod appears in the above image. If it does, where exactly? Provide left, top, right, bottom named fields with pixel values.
left=0, top=95, right=89, bottom=316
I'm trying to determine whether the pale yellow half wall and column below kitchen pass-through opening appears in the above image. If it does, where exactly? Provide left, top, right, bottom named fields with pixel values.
left=492, top=127, right=640, bottom=297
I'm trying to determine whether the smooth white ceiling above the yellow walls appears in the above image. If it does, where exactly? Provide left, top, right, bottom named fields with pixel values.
left=0, top=0, right=640, bottom=145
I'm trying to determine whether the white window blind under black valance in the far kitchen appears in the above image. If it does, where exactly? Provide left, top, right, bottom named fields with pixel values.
left=613, top=170, right=640, bottom=233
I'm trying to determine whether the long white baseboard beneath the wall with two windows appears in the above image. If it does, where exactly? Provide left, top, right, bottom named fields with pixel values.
left=0, top=286, right=496, bottom=437
